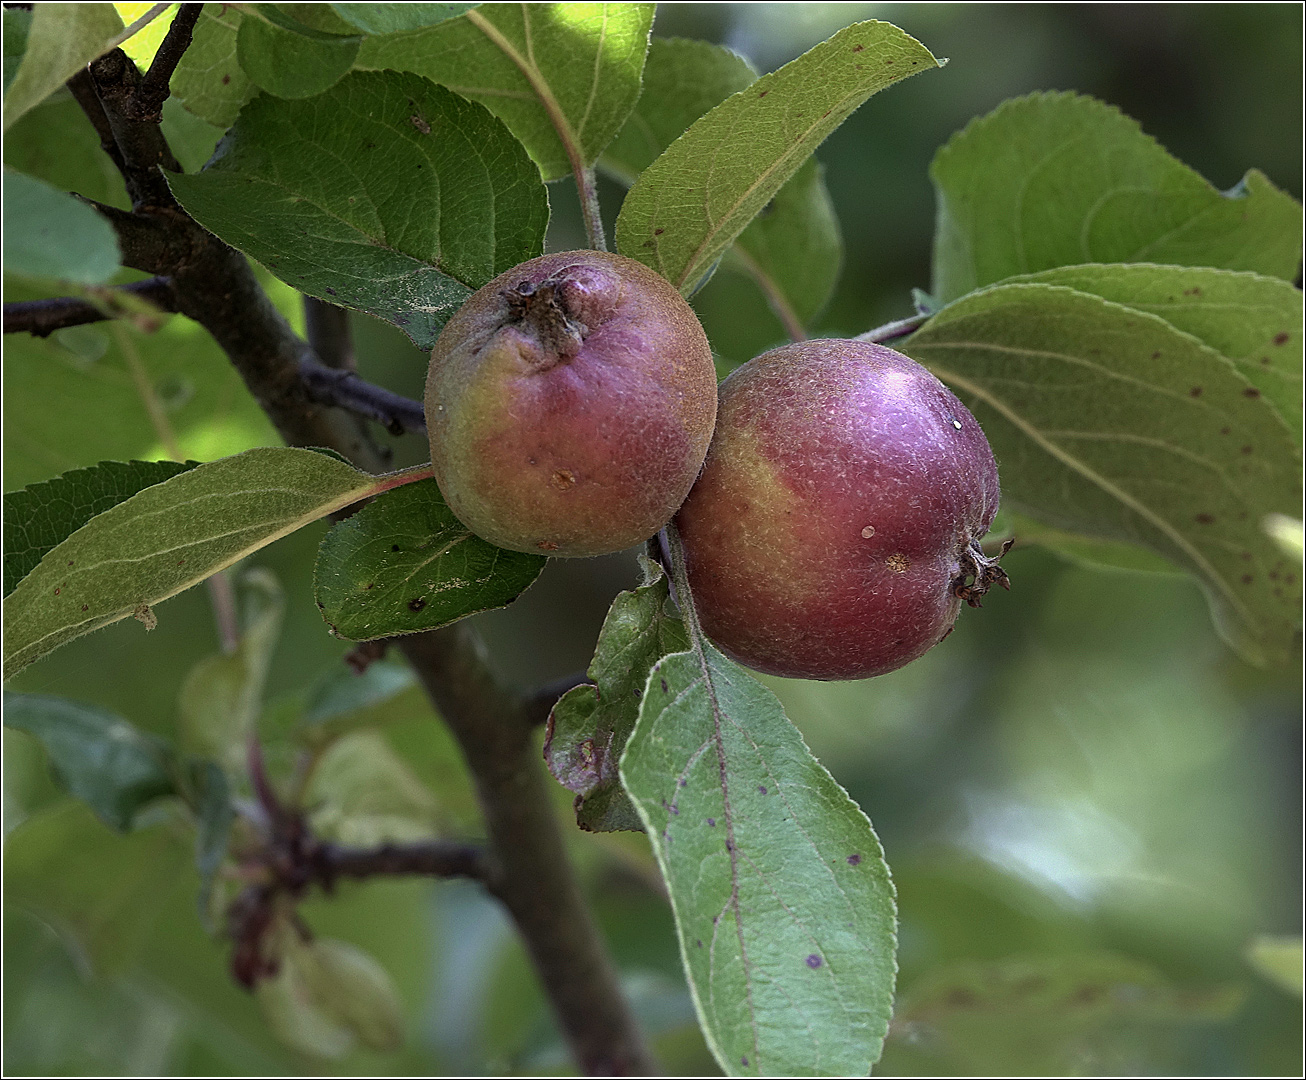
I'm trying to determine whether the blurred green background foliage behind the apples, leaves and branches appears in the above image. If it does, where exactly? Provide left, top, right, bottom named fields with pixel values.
left=4, top=4, right=1302, bottom=1075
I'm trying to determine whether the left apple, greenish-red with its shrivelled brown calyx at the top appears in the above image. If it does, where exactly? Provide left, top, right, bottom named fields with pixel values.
left=426, top=251, right=717, bottom=556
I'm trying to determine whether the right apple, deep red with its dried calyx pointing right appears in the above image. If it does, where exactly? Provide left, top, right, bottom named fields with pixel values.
left=677, top=340, right=1007, bottom=679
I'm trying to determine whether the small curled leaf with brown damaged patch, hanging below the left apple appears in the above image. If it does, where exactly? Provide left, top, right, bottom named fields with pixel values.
left=545, top=560, right=690, bottom=832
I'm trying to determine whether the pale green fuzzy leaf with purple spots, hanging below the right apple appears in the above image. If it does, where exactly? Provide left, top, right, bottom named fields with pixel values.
left=622, top=639, right=896, bottom=1076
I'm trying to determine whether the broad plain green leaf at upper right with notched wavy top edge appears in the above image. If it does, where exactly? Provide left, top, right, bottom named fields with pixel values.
left=930, top=93, right=1302, bottom=302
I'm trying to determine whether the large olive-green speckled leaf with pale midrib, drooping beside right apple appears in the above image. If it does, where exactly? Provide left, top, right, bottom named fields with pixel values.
left=900, top=283, right=1301, bottom=662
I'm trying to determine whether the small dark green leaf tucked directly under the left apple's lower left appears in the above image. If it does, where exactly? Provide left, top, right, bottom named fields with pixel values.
left=313, top=479, right=547, bottom=641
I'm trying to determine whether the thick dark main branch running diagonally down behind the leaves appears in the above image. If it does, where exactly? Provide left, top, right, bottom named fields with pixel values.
left=70, top=44, right=654, bottom=1075
